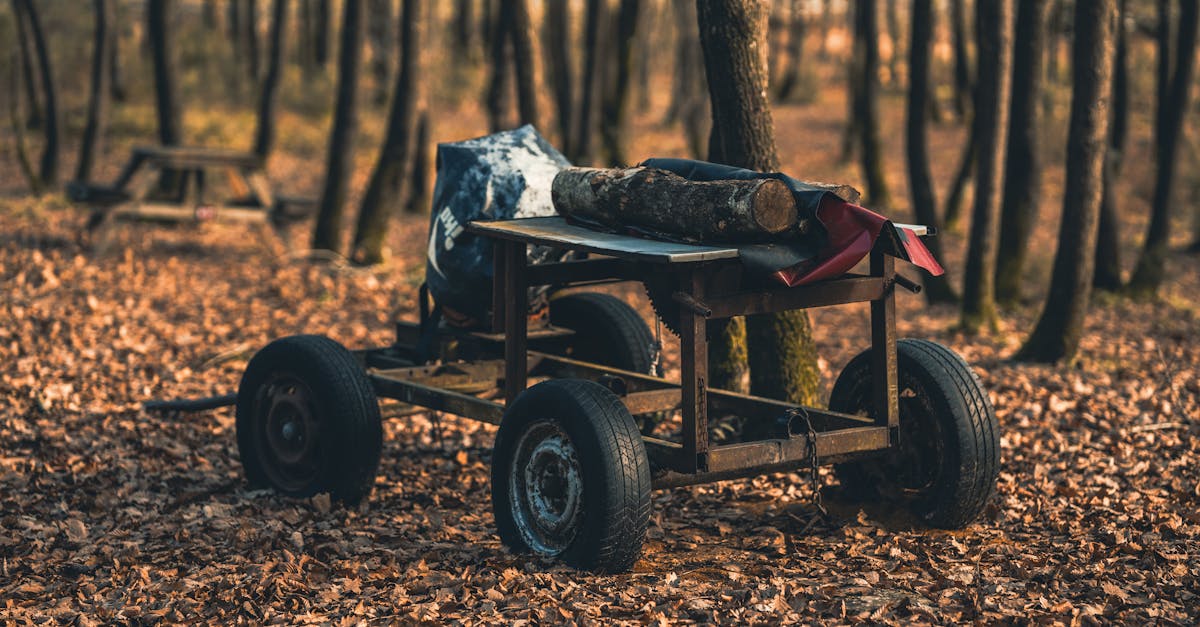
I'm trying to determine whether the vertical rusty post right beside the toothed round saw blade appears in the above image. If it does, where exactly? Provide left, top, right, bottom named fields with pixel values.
left=679, top=268, right=708, bottom=472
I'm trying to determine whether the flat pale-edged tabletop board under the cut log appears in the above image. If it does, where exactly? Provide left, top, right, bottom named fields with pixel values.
left=467, top=216, right=738, bottom=263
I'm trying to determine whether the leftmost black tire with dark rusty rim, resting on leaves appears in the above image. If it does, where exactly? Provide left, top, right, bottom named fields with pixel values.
left=236, top=335, right=383, bottom=503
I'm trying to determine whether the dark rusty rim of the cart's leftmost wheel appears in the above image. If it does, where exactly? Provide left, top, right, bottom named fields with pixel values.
left=254, top=372, right=320, bottom=491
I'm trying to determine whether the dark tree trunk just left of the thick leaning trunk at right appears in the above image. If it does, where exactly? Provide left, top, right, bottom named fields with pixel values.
left=996, top=0, right=1048, bottom=304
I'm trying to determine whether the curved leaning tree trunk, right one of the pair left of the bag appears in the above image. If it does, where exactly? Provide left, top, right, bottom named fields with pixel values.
left=352, top=0, right=424, bottom=260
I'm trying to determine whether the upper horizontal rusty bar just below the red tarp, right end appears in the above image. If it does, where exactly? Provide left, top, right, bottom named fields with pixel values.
left=704, top=276, right=884, bottom=318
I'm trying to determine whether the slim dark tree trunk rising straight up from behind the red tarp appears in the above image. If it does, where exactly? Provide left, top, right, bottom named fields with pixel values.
left=854, top=0, right=892, bottom=209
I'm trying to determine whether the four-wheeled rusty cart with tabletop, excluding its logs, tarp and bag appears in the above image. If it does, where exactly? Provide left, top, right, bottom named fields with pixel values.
left=229, top=217, right=998, bottom=571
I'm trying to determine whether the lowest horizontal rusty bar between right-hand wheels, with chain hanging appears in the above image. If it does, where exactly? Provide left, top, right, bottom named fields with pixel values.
left=648, top=426, right=888, bottom=490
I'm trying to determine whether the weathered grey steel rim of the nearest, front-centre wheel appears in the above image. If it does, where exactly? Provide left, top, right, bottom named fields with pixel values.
left=509, top=420, right=583, bottom=556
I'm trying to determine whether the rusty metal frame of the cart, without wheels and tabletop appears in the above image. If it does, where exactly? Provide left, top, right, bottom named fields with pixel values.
left=362, top=227, right=899, bottom=488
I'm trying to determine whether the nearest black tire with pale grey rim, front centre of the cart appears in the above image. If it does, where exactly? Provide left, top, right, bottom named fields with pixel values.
left=492, top=378, right=650, bottom=573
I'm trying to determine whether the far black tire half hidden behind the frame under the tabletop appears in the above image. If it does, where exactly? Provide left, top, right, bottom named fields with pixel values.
left=550, top=292, right=654, bottom=375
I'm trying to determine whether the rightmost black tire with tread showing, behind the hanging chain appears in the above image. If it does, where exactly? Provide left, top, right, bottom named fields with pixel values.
left=829, top=340, right=1000, bottom=529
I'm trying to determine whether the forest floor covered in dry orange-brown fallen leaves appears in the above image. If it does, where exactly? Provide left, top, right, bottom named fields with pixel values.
left=0, top=72, right=1200, bottom=625
